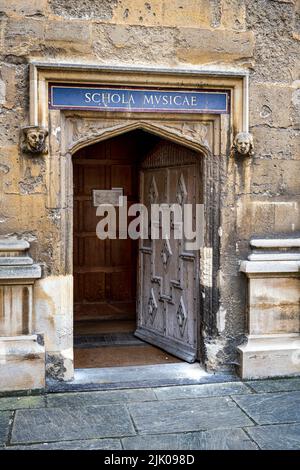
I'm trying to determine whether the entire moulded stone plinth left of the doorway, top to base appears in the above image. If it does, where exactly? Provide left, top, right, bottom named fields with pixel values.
left=0, top=238, right=45, bottom=391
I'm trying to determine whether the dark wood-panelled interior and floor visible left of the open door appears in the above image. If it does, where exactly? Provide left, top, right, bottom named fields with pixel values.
left=73, top=131, right=183, bottom=368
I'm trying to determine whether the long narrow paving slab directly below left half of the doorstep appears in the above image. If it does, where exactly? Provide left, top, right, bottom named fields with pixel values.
left=47, top=389, right=156, bottom=407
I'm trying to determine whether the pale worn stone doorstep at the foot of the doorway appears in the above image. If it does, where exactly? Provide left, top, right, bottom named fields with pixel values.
left=46, top=363, right=239, bottom=393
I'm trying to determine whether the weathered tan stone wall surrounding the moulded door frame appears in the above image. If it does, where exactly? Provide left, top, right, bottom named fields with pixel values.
left=0, top=0, right=300, bottom=374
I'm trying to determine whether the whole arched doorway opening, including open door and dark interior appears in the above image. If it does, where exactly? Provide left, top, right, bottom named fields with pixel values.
left=73, top=130, right=202, bottom=368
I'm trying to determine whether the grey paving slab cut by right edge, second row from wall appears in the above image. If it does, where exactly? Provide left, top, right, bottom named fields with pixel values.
left=233, top=392, right=300, bottom=424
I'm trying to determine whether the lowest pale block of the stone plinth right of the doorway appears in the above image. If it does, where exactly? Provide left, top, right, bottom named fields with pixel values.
left=237, top=334, right=300, bottom=379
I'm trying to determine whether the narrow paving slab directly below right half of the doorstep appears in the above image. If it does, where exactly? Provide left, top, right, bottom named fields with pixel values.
left=154, top=382, right=252, bottom=400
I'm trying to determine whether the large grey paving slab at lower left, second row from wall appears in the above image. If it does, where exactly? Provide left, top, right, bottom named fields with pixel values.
left=11, top=405, right=135, bottom=444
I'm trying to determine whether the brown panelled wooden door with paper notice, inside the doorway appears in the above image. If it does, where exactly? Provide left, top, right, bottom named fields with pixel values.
left=73, top=134, right=138, bottom=320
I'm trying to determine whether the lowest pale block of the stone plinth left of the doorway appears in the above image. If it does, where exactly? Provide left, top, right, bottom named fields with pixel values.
left=0, top=335, right=45, bottom=392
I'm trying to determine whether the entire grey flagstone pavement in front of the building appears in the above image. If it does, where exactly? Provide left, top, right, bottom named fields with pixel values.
left=0, top=377, right=300, bottom=450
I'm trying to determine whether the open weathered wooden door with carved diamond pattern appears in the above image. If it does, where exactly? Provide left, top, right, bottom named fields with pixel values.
left=136, top=141, right=201, bottom=362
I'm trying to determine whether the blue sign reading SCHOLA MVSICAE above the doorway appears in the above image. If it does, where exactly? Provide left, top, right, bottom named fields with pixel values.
left=49, top=85, right=229, bottom=114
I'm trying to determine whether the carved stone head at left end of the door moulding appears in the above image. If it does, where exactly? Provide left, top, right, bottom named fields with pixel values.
left=21, top=126, right=48, bottom=156
